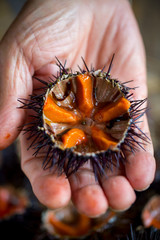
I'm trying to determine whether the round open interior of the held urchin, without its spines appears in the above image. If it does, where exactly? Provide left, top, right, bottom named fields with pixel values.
left=43, top=71, right=130, bottom=155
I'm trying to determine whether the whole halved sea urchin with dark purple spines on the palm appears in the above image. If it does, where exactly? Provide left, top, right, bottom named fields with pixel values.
left=19, top=56, right=148, bottom=178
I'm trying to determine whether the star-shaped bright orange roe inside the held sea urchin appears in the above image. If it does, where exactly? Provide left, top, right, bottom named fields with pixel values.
left=43, top=73, right=131, bottom=154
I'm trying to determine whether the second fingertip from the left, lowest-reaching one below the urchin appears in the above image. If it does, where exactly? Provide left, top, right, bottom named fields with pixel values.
left=69, top=164, right=108, bottom=217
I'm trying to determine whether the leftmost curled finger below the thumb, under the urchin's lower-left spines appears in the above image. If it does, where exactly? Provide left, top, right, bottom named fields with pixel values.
left=21, top=135, right=71, bottom=208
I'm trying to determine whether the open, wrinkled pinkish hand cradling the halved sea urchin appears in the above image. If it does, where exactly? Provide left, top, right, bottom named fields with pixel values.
left=0, top=0, right=155, bottom=217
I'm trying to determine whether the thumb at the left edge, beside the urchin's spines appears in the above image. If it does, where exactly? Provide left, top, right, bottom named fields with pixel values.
left=0, top=38, right=32, bottom=150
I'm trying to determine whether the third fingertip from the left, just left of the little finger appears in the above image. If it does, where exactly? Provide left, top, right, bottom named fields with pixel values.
left=102, top=176, right=136, bottom=211
